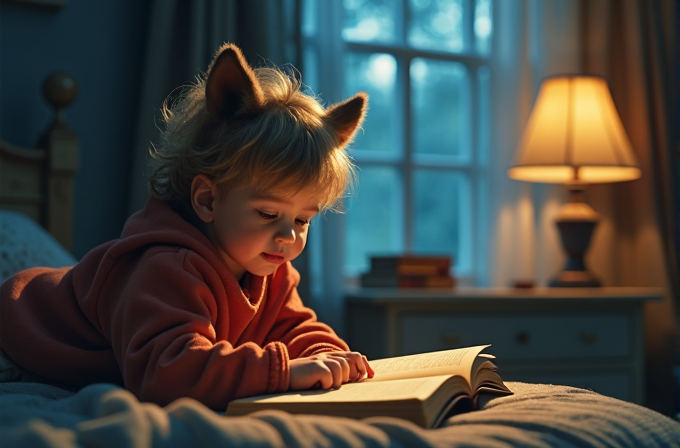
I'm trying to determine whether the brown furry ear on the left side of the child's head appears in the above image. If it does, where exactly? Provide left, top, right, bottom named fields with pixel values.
left=205, top=44, right=264, bottom=118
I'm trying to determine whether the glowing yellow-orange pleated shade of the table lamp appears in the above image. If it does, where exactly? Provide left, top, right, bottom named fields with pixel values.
left=508, top=76, right=640, bottom=183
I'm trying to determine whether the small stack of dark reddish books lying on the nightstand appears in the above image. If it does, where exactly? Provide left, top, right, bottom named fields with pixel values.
left=361, top=255, right=456, bottom=288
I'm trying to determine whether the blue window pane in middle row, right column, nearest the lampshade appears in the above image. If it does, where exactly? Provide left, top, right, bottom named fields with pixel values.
left=410, top=58, right=471, bottom=158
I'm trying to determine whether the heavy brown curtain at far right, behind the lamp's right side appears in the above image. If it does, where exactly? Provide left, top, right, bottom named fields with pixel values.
left=582, top=0, right=680, bottom=414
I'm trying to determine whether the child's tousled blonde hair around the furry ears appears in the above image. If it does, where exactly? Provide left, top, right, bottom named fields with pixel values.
left=148, top=67, right=356, bottom=211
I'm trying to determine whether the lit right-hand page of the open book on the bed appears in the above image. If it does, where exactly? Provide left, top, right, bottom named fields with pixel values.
left=364, top=345, right=489, bottom=384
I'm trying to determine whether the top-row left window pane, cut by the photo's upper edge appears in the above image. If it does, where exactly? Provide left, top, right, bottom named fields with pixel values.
left=342, top=0, right=399, bottom=42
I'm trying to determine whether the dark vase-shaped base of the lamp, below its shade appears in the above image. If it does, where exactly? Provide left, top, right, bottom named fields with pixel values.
left=550, top=183, right=601, bottom=288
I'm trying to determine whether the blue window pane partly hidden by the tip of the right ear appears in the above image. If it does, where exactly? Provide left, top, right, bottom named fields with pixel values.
left=345, top=53, right=401, bottom=153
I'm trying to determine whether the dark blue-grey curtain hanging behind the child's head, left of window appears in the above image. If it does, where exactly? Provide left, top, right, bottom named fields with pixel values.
left=129, top=0, right=300, bottom=214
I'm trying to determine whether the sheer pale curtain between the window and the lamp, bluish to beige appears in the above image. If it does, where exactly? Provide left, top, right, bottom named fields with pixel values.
left=483, top=0, right=584, bottom=286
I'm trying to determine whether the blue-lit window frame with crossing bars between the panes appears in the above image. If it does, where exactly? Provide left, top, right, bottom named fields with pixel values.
left=301, top=0, right=491, bottom=285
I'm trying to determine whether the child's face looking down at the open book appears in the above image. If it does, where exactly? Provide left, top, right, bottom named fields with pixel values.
left=209, top=184, right=319, bottom=279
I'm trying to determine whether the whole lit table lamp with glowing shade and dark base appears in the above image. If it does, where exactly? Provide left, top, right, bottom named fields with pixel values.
left=508, top=76, right=640, bottom=287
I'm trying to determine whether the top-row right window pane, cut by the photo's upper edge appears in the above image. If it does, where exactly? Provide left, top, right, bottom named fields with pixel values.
left=408, top=0, right=464, bottom=52
